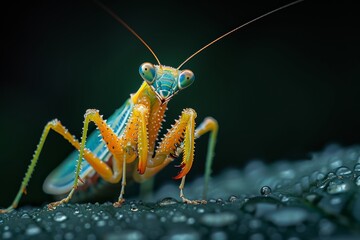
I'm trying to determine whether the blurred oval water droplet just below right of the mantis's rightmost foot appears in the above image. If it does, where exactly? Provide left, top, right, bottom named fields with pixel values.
left=200, top=212, right=237, bottom=227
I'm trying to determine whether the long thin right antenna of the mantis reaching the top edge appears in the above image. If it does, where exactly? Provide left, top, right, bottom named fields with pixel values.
left=177, top=0, right=304, bottom=69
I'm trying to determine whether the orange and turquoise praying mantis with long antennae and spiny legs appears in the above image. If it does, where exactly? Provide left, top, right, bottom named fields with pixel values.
left=0, top=0, right=303, bottom=213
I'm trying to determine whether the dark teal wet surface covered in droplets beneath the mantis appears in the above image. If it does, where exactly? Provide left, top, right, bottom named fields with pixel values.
left=0, top=145, right=360, bottom=240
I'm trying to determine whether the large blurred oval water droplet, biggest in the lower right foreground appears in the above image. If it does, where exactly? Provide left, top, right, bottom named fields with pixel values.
left=266, top=207, right=308, bottom=227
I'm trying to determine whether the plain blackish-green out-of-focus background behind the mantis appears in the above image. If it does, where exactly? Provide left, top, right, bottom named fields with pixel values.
left=0, top=1, right=360, bottom=206
